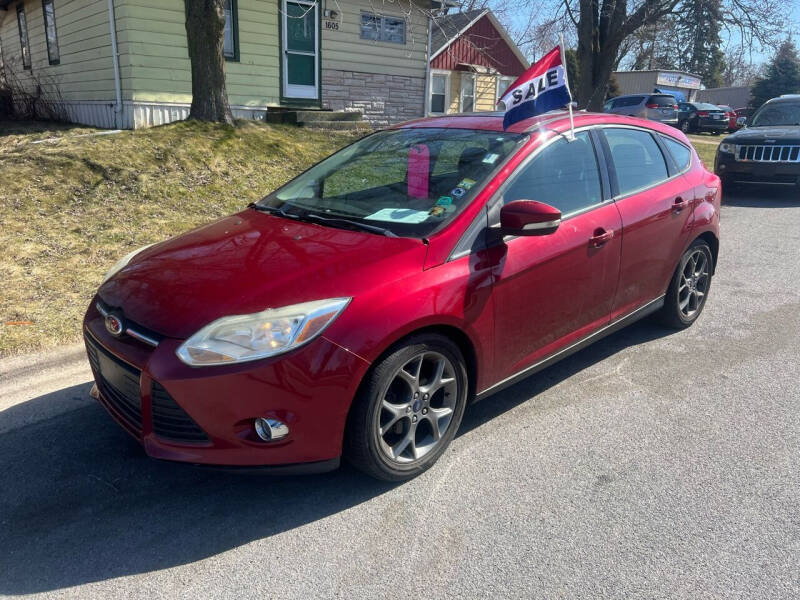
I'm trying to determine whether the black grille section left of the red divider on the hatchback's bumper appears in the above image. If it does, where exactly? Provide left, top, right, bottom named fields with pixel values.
left=84, top=335, right=142, bottom=435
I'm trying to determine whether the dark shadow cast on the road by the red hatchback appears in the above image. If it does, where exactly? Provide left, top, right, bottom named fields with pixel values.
left=0, top=321, right=670, bottom=595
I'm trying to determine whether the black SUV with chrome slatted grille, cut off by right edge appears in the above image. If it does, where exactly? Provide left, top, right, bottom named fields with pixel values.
left=714, top=95, right=800, bottom=188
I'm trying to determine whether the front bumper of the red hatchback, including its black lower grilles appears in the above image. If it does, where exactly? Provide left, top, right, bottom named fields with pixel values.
left=84, top=302, right=369, bottom=472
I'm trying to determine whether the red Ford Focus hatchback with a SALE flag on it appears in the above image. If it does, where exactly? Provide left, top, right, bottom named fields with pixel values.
left=84, top=112, right=720, bottom=481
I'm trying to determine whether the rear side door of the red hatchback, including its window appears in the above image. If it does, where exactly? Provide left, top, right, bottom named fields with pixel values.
left=600, top=126, right=694, bottom=318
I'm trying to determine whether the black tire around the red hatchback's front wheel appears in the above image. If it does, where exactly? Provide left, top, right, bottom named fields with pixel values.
left=344, top=334, right=469, bottom=482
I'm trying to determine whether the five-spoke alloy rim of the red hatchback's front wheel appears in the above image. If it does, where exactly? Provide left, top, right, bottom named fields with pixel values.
left=376, top=351, right=459, bottom=463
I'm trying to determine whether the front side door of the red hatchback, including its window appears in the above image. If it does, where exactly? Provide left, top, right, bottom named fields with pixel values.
left=490, top=131, right=622, bottom=379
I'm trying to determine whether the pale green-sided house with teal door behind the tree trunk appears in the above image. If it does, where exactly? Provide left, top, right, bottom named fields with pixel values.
left=0, top=0, right=431, bottom=128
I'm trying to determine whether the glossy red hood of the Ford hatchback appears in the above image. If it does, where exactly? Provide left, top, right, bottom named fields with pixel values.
left=98, top=210, right=426, bottom=338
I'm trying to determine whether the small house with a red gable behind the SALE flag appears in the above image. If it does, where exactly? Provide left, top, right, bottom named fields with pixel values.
left=426, top=9, right=529, bottom=115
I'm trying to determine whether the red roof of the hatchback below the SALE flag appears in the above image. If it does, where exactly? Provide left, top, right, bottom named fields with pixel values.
left=394, top=110, right=682, bottom=139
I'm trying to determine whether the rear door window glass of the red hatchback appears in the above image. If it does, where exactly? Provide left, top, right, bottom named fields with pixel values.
left=602, top=127, right=669, bottom=196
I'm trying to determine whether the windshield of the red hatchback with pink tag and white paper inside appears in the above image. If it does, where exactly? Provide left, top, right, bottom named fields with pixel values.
left=256, top=128, right=528, bottom=237
